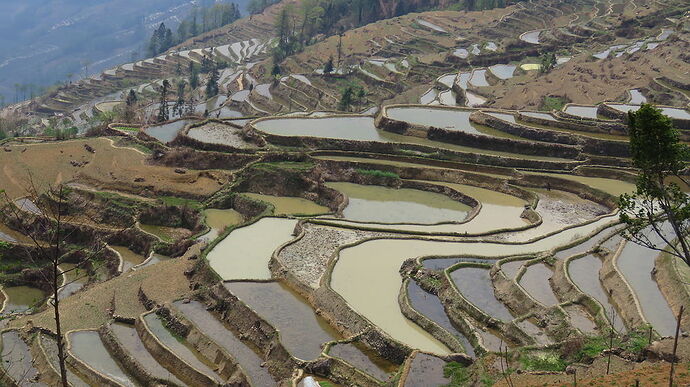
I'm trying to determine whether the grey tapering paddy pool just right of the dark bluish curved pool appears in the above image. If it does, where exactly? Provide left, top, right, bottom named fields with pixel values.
left=450, top=267, right=513, bottom=321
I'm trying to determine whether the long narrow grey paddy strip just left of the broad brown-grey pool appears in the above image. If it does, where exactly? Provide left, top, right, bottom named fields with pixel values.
left=174, top=301, right=276, bottom=386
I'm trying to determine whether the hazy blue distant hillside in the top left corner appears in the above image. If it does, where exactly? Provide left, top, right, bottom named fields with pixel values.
left=0, top=0, right=244, bottom=103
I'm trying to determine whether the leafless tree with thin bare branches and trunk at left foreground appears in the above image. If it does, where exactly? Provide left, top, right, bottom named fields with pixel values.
left=0, top=183, right=133, bottom=386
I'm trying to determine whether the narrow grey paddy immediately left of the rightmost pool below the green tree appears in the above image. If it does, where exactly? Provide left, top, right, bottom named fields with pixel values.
left=568, top=255, right=625, bottom=331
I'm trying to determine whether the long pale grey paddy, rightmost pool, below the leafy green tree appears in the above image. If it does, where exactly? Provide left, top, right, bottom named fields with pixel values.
left=616, top=235, right=676, bottom=336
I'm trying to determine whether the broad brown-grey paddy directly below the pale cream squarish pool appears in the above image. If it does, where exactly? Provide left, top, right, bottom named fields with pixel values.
left=224, top=282, right=340, bottom=360
